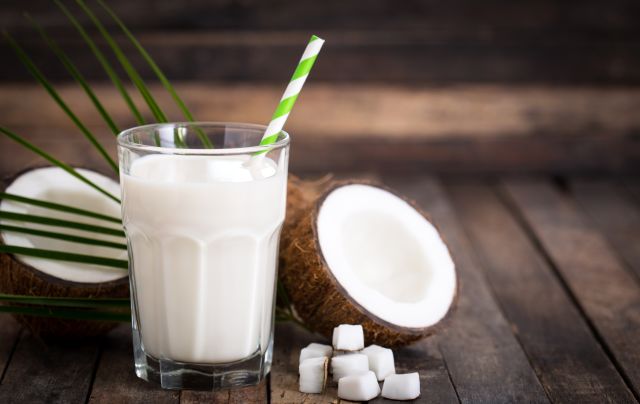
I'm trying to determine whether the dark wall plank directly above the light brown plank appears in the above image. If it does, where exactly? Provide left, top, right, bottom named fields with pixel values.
left=0, top=28, right=640, bottom=85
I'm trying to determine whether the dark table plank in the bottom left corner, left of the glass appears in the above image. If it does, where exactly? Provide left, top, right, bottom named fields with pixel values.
left=0, top=332, right=99, bottom=404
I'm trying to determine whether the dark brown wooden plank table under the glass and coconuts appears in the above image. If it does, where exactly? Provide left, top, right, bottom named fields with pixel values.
left=0, top=176, right=640, bottom=404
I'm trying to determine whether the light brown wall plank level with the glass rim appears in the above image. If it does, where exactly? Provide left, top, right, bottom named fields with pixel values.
left=0, top=83, right=640, bottom=140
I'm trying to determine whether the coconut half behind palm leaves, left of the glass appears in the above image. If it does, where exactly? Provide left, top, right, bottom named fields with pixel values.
left=0, top=167, right=129, bottom=336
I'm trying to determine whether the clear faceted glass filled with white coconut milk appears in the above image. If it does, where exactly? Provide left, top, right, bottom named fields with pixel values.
left=118, top=122, right=289, bottom=390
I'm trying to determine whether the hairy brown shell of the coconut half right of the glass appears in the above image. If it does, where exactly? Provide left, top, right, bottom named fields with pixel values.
left=280, top=181, right=457, bottom=347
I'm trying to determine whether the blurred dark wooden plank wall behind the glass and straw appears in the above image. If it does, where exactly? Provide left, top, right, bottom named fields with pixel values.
left=0, top=0, right=640, bottom=174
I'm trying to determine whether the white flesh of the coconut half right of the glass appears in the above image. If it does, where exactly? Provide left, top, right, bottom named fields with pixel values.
left=317, top=184, right=456, bottom=328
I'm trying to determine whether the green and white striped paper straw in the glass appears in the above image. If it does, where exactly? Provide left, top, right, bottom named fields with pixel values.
left=260, top=35, right=324, bottom=145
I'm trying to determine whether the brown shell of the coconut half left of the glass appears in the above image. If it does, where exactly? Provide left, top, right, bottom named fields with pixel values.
left=0, top=167, right=129, bottom=338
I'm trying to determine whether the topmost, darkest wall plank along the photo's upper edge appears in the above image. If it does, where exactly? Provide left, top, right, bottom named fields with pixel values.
left=0, top=0, right=640, bottom=36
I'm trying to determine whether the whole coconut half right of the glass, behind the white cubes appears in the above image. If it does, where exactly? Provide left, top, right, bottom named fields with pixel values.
left=281, top=183, right=457, bottom=346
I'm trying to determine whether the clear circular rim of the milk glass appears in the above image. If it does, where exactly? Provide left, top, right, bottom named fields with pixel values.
left=117, top=121, right=290, bottom=156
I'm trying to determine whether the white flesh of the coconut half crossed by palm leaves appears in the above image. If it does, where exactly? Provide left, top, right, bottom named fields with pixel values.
left=0, top=167, right=127, bottom=283
